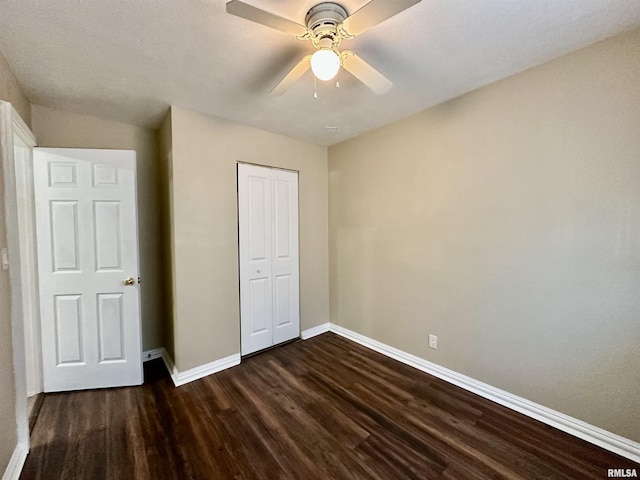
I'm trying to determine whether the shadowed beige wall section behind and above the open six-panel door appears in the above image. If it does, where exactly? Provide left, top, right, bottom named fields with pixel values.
left=31, top=105, right=164, bottom=350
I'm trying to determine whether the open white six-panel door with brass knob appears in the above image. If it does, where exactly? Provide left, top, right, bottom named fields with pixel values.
left=34, top=148, right=143, bottom=392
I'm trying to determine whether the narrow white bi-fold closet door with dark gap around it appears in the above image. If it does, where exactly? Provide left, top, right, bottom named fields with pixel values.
left=238, top=164, right=300, bottom=355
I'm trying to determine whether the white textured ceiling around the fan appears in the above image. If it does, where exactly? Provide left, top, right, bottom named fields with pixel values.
left=0, top=0, right=640, bottom=145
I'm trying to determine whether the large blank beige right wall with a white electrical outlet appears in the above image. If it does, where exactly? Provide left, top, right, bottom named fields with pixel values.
left=329, top=31, right=640, bottom=441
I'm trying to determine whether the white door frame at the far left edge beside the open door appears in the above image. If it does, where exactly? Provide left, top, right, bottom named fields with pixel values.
left=0, top=102, right=38, bottom=468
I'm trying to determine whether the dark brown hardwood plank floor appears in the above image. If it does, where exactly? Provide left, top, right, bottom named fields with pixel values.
left=21, top=333, right=640, bottom=480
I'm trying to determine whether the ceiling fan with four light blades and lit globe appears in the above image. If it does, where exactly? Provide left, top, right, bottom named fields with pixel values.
left=227, top=0, right=421, bottom=95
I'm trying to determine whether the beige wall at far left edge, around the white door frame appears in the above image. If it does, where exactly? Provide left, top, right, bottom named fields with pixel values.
left=0, top=47, right=31, bottom=473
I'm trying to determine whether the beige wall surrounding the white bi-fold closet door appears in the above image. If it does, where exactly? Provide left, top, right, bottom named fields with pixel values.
left=171, top=107, right=329, bottom=370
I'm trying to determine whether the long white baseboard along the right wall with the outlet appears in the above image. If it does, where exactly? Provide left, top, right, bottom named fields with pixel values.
left=324, top=323, right=640, bottom=462
